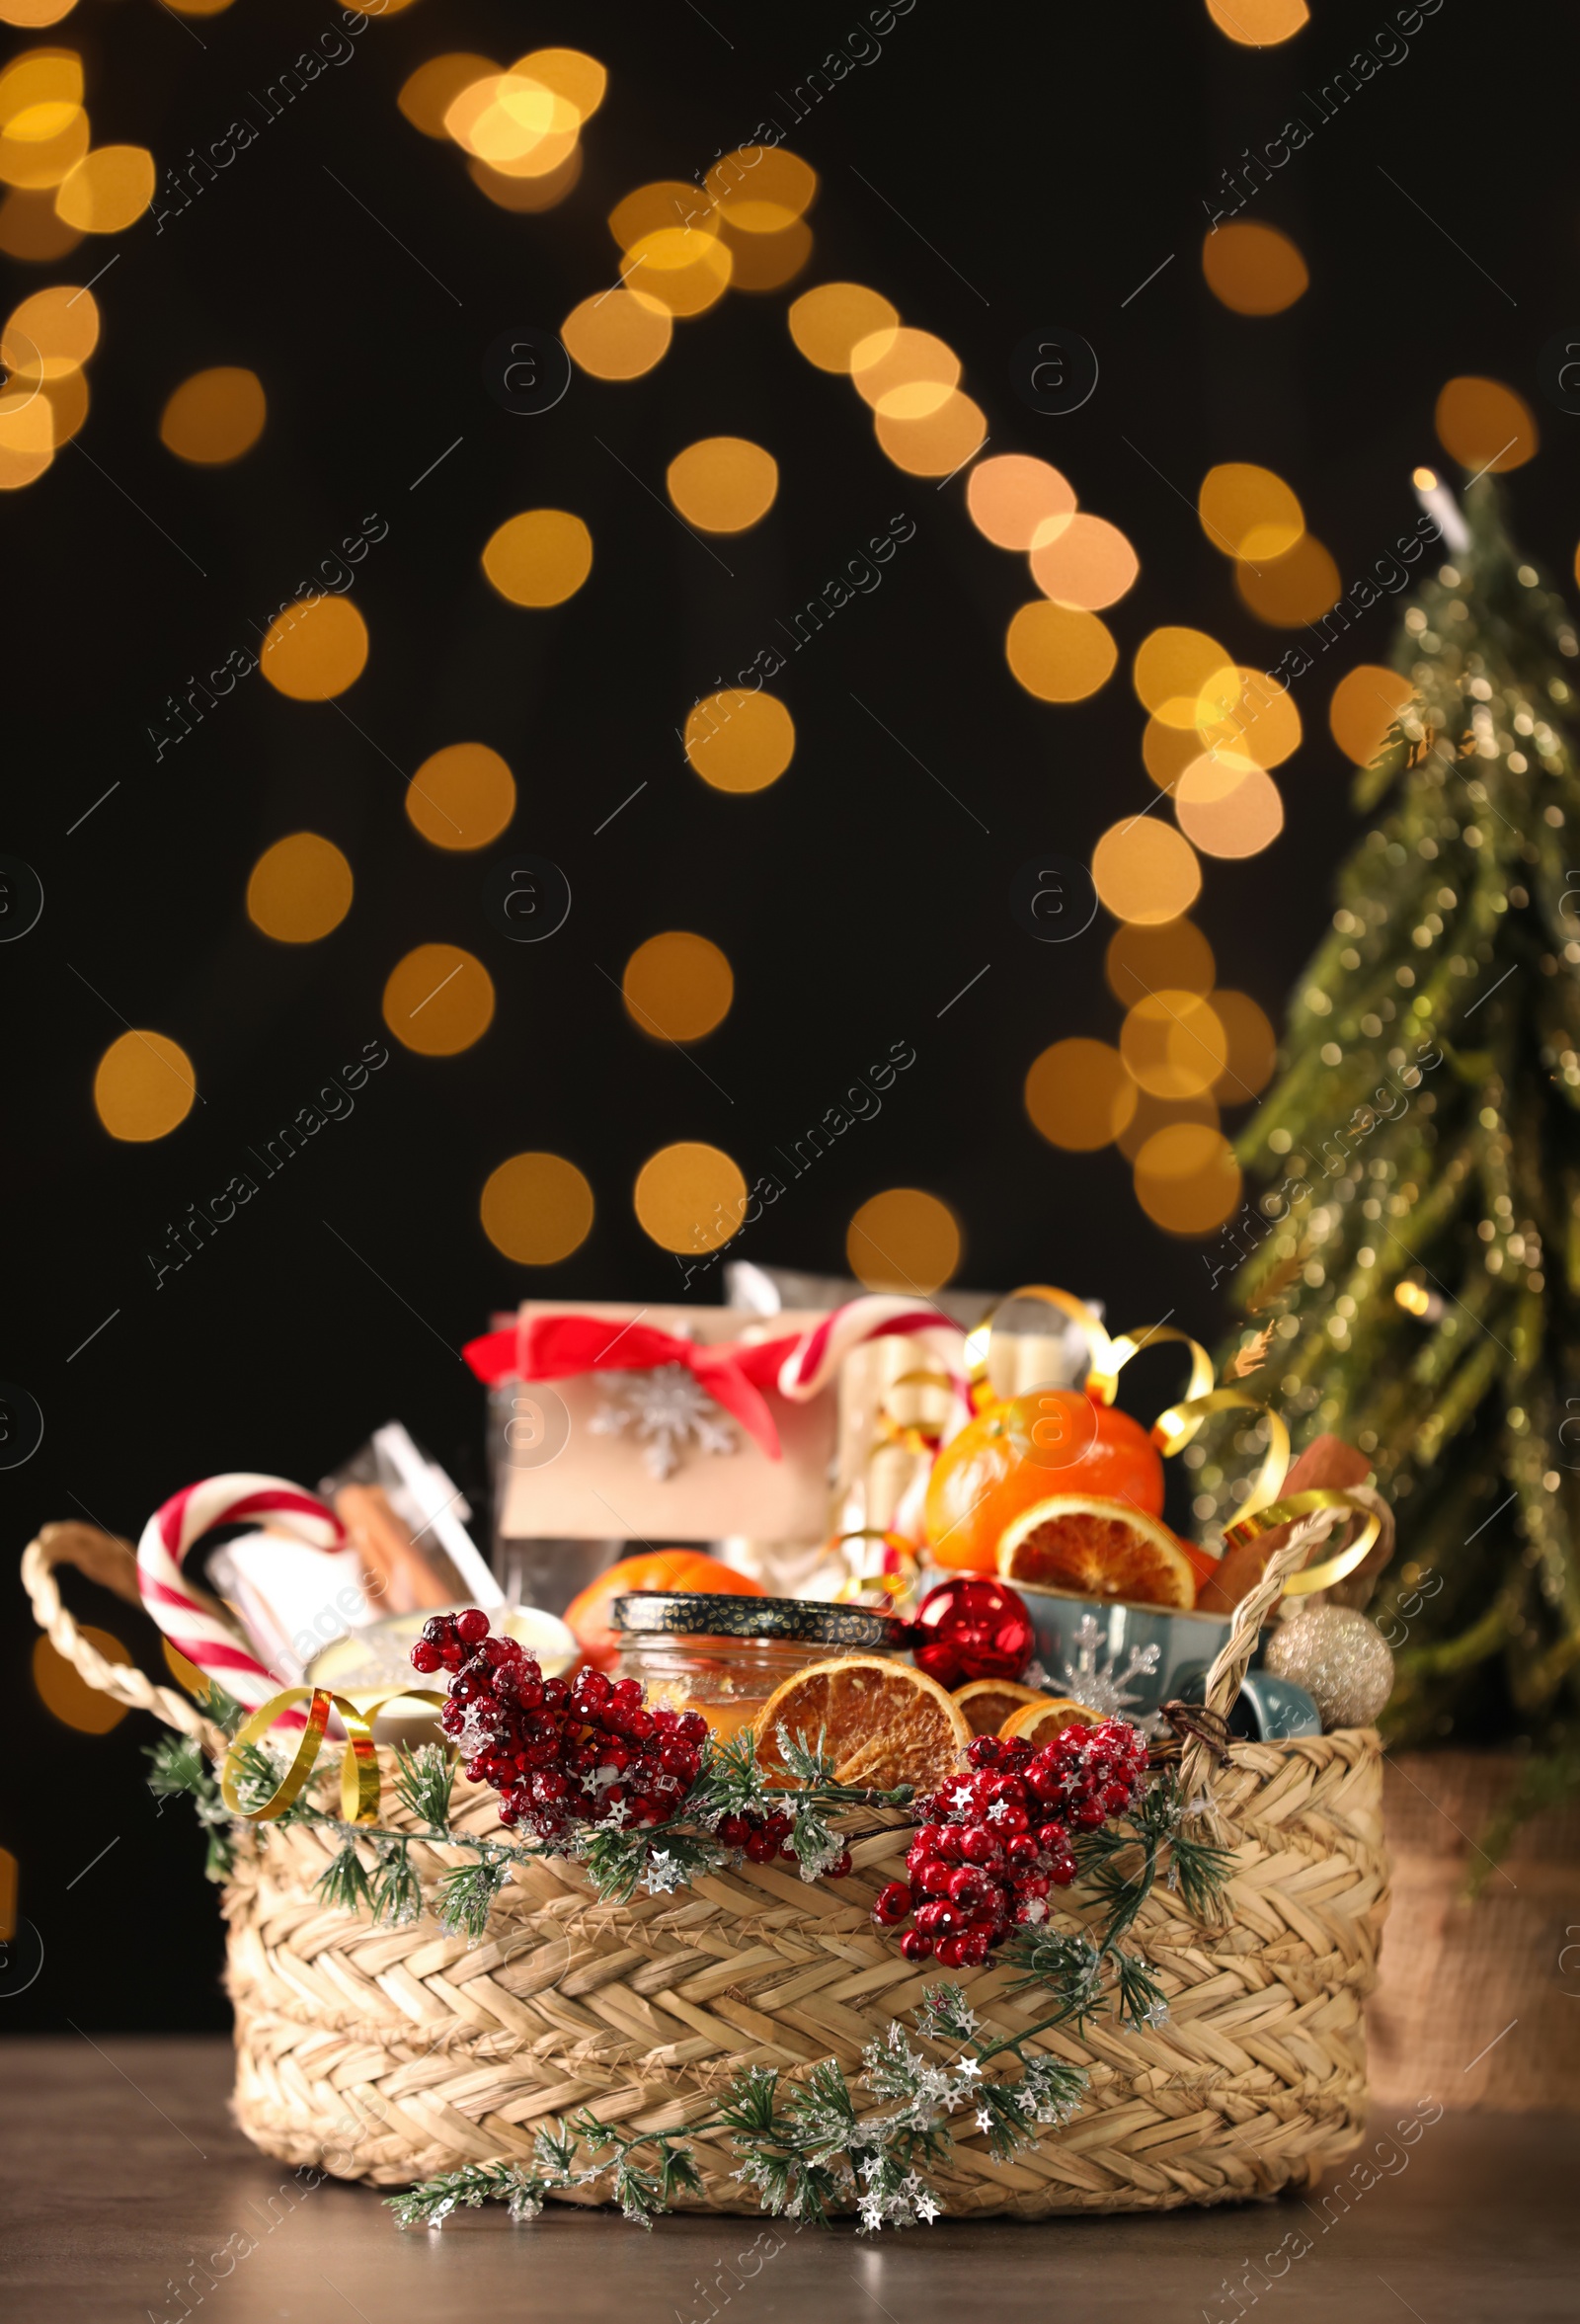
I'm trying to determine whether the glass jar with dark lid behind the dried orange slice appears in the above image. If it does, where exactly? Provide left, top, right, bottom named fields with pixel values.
left=611, top=1589, right=907, bottom=1736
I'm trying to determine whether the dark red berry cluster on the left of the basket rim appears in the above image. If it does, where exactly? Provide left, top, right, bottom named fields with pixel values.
left=411, top=1606, right=706, bottom=1850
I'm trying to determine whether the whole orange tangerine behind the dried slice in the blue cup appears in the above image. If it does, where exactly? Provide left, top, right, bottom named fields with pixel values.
left=927, top=1388, right=1164, bottom=1573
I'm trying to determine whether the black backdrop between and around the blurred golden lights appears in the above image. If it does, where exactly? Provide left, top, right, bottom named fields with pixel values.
left=0, top=0, right=1580, bottom=2032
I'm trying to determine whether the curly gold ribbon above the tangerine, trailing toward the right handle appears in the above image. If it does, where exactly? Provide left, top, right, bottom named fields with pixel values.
left=964, top=1283, right=1381, bottom=1597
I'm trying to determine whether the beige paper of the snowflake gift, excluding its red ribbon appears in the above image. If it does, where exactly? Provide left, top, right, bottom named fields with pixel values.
left=498, top=1299, right=836, bottom=1548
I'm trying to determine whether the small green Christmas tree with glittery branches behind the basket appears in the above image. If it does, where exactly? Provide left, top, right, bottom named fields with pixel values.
left=1197, top=462, right=1580, bottom=1803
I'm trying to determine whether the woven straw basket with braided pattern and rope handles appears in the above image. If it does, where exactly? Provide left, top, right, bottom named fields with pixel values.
left=24, top=1525, right=1387, bottom=2219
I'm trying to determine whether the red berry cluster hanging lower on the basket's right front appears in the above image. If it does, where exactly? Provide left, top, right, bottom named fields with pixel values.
left=871, top=1720, right=1146, bottom=1968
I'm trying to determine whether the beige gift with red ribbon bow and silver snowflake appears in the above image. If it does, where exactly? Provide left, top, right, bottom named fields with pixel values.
left=467, top=1299, right=836, bottom=1564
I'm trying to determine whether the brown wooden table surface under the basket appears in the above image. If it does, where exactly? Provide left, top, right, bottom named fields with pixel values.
left=0, top=2034, right=1580, bottom=2324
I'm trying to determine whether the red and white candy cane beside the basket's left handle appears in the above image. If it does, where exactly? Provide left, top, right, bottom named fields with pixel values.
left=137, top=1471, right=347, bottom=1726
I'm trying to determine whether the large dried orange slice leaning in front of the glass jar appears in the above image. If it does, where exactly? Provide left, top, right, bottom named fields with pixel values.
left=752, top=1654, right=972, bottom=1792
